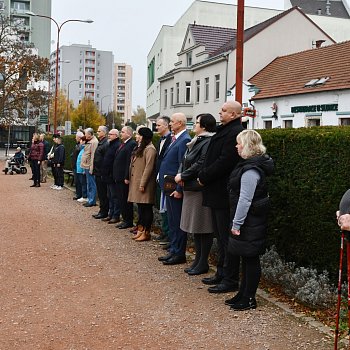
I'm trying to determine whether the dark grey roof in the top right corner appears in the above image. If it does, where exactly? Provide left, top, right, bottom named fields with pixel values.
left=291, top=0, right=350, bottom=18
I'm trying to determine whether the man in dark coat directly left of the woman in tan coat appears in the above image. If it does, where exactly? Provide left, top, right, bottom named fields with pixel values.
left=113, top=126, right=136, bottom=229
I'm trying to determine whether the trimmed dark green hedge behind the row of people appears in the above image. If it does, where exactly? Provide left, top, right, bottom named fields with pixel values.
left=63, top=127, right=350, bottom=278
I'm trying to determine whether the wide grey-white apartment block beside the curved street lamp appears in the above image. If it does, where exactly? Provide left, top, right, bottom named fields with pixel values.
left=50, top=44, right=114, bottom=114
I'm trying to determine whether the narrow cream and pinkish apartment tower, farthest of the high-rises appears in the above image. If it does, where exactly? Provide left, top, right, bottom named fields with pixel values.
left=113, top=63, right=132, bottom=123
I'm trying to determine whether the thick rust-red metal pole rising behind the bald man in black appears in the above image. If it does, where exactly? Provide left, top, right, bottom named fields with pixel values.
left=235, top=0, right=244, bottom=104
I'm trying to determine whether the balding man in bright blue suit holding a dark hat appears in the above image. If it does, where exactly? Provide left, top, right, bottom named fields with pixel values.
left=158, top=113, right=191, bottom=265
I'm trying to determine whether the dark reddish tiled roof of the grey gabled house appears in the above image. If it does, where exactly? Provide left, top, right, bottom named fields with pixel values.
left=183, top=24, right=237, bottom=55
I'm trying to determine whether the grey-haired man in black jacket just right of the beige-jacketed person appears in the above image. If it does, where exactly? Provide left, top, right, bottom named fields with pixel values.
left=92, top=126, right=109, bottom=219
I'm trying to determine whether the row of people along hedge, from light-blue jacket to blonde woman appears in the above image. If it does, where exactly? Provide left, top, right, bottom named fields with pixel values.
left=71, top=101, right=273, bottom=310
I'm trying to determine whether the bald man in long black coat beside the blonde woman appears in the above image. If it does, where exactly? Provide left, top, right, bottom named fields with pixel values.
left=198, top=101, right=243, bottom=293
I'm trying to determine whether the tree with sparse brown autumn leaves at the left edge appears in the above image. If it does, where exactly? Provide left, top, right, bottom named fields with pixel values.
left=0, top=16, right=49, bottom=124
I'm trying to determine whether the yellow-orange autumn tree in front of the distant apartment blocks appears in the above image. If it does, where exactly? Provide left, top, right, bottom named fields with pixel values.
left=70, top=97, right=105, bottom=130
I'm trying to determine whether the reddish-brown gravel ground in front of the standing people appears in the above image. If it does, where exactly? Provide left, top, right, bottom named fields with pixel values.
left=0, top=162, right=333, bottom=350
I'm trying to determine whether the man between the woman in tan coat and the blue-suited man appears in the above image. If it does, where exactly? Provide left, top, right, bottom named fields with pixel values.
left=156, top=116, right=171, bottom=247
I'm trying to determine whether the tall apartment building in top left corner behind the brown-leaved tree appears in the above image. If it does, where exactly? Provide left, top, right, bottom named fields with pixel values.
left=0, top=0, right=51, bottom=58
